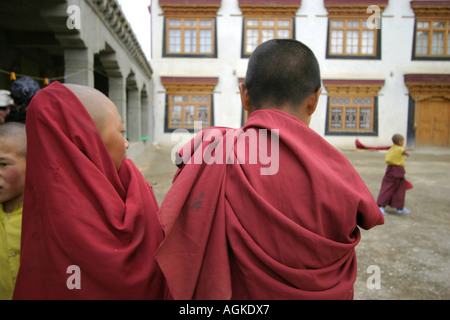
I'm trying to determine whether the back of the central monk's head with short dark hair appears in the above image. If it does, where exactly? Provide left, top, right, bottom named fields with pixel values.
left=245, top=39, right=321, bottom=109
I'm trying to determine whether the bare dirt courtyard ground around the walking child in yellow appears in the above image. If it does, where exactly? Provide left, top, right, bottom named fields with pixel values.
left=135, top=146, right=450, bottom=300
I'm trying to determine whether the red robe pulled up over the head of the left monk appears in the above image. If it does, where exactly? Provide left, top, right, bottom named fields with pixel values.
left=13, top=82, right=167, bottom=299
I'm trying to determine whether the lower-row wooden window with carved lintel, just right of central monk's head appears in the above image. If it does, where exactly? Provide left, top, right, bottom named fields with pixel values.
left=323, top=80, right=384, bottom=136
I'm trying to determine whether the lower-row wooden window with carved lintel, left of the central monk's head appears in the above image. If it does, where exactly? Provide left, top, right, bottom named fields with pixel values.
left=161, top=77, right=218, bottom=132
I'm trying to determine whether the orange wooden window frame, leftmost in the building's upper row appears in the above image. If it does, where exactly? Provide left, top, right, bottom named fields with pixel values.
left=163, top=17, right=217, bottom=58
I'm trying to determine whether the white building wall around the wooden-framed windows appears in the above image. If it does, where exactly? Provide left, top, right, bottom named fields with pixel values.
left=151, top=0, right=450, bottom=148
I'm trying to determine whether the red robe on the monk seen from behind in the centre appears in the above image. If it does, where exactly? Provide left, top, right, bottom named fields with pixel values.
left=156, top=110, right=384, bottom=300
